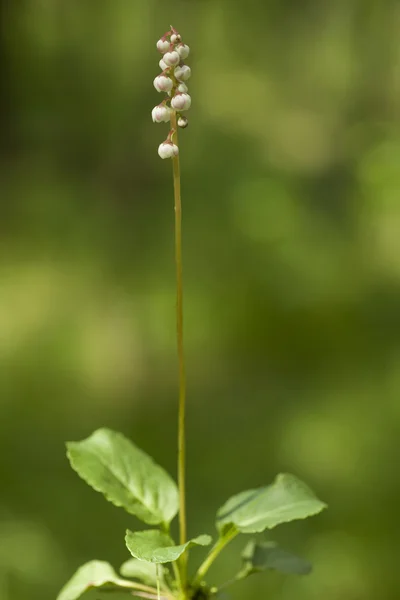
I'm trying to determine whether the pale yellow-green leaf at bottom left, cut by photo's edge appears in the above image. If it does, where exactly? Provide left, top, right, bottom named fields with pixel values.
left=57, top=560, right=138, bottom=600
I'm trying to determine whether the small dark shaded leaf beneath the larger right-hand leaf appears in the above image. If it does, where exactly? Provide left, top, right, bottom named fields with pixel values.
left=237, top=540, right=312, bottom=579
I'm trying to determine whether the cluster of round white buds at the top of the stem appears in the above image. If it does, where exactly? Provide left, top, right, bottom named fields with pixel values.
left=151, top=26, right=192, bottom=158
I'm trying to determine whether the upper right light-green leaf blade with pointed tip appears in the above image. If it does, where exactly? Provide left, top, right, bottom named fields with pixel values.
left=217, top=474, right=326, bottom=534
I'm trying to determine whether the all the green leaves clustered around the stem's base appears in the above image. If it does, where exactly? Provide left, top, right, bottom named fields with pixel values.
left=58, top=429, right=326, bottom=600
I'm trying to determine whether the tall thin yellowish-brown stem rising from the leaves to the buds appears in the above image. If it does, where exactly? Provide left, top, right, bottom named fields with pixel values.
left=171, top=111, right=187, bottom=587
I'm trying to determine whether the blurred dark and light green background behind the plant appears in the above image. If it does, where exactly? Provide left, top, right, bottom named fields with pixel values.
left=0, top=0, right=400, bottom=600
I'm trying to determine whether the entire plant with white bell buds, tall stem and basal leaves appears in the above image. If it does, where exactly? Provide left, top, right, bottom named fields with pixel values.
left=57, top=27, right=326, bottom=600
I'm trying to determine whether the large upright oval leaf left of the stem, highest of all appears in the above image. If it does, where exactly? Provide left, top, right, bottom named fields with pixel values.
left=67, top=429, right=179, bottom=525
